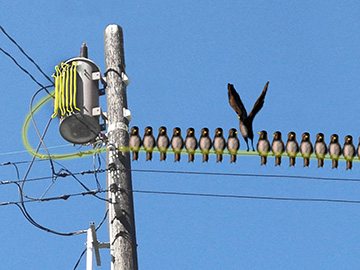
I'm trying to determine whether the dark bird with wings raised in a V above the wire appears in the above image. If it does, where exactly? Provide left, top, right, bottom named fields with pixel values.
left=228, top=82, right=269, bottom=151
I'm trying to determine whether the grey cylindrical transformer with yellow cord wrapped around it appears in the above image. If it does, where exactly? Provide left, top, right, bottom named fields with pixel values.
left=53, top=43, right=102, bottom=144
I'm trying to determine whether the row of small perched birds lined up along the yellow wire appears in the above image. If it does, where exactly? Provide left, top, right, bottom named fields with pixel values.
left=129, top=126, right=360, bottom=169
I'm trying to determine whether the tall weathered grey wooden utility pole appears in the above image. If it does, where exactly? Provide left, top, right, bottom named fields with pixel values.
left=104, top=25, right=138, bottom=270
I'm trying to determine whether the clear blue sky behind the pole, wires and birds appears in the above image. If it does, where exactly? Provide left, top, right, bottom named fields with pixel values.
left=0, top=0, right=360, bottom=269
